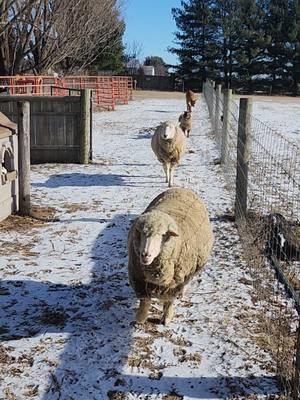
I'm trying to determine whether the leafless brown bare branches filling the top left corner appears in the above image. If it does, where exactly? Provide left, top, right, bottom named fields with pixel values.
left=0, top=0, right=123, bottom=75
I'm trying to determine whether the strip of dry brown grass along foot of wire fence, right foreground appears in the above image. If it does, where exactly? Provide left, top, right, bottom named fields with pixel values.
left=239, top=215, right=299, bottom=392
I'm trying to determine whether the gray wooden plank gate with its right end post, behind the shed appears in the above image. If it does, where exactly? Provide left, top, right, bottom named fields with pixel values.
left=0, top=90, right=92, bottom=163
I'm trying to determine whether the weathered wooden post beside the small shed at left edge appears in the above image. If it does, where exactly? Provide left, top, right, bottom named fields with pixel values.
left=17, top=101, right=30, bottom=217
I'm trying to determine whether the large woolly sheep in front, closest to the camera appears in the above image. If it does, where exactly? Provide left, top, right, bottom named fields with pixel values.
left=128, top=188, right=213, bottom=325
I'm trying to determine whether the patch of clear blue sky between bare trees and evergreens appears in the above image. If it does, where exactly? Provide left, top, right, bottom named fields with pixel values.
left=123, top=0, right=181, bottom=64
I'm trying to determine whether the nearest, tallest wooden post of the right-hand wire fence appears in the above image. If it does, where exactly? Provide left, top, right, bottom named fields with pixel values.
left=235, top=98, right=252, bottom=221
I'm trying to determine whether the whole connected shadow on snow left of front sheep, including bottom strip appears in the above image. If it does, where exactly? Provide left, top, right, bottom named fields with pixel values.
left=0, top=214, right=275, bottom=400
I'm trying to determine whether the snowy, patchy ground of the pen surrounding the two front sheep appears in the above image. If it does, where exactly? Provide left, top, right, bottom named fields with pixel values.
left=0, top=96, right=284, bottom=400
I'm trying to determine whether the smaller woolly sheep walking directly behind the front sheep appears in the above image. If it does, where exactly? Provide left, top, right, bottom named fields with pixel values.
left=151, top=121, right=186, bottom=187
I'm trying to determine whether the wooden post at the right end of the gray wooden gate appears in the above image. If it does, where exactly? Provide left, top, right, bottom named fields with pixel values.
left=79, top=89, right=91, bottom=164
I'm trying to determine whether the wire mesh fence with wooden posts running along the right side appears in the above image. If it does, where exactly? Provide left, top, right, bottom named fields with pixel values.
left=203, top=82, right=300, bottom=399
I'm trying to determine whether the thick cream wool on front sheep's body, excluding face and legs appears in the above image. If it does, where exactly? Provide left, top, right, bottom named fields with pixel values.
left=128, top=188, right=213, bottom=298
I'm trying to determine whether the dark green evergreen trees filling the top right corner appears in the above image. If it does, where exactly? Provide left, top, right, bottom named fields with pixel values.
left=170, top=0, right=300, bottom=93
